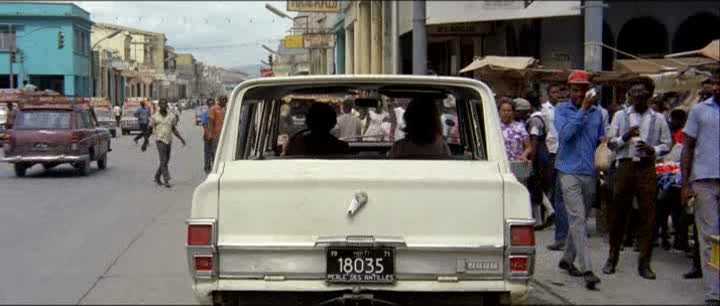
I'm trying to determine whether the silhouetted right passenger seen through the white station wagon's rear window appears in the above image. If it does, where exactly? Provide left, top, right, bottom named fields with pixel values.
left=388, top=99, right=452, bottom=159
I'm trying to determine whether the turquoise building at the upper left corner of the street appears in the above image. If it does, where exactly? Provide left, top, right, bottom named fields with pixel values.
left=0, top=2, right=92, bottom=96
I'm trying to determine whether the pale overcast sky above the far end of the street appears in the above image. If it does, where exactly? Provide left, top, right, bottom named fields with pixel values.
left=74, top=1, right=294, bottom=68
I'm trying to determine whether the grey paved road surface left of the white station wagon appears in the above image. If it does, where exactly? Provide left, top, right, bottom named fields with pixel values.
left=0, top=112, right=204, bottom=304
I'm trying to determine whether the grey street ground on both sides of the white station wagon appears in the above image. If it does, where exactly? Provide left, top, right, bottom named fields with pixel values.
left=0, top=111, right=702, bottom=304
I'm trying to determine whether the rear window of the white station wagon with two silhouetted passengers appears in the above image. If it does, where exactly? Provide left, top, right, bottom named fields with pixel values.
left=236, top=84, right=485, bottom=160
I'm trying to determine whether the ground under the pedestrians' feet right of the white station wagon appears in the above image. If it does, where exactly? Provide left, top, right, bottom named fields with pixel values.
left=534, top=218, right=704, bottom=305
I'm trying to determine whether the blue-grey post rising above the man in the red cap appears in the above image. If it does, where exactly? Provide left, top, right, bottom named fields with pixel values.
left=584, top=0, right=605, bottom=72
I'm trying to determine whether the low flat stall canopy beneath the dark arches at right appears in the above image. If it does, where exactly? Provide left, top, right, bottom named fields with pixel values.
left=615, top=57, right=717, bottom=74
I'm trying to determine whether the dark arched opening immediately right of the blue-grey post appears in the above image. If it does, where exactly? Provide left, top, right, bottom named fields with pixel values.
left=617, top=16, right=668, bottom=58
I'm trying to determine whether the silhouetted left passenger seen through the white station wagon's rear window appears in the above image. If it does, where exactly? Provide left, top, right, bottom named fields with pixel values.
left=287, top=102, right=350, bottom=156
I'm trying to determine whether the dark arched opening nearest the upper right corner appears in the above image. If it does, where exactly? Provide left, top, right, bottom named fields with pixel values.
left=673, top=12, right=720, bottom=52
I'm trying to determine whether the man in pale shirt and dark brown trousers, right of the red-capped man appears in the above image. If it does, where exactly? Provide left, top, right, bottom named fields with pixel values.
left=603, top=78, right=672, bottom=279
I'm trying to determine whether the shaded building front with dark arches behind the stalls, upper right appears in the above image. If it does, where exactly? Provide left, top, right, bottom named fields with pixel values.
left=394, top=1, right=720, bottom=75
